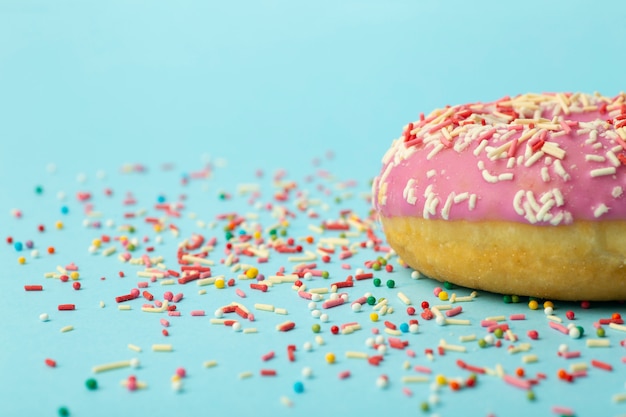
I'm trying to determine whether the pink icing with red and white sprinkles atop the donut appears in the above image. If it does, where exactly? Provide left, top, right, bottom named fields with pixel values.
left=373, top=93, right=626, bottom=225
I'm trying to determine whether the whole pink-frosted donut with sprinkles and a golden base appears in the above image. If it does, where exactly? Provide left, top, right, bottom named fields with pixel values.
left=372, top=93, right=626, bottom=301
